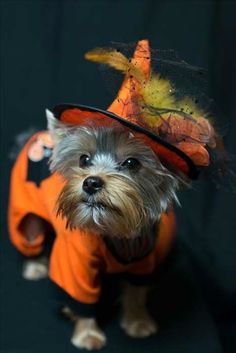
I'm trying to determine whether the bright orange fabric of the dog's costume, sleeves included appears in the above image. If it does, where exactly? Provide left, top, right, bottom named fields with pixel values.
left=9, top=134, right=175, bottom=303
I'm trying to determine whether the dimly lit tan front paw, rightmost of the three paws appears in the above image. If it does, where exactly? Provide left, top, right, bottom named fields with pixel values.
left=121, top=314, right=158, bottom=338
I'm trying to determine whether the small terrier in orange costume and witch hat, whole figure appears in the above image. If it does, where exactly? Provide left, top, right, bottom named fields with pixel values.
left=9, top=40, right=218, bottom=350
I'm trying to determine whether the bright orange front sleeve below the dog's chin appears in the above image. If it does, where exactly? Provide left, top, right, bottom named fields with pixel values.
left=49, top=232, right=101, bottom=304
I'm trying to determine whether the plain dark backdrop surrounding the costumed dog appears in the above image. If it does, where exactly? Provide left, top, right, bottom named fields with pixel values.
left=0, top=0, right=236, bottom=353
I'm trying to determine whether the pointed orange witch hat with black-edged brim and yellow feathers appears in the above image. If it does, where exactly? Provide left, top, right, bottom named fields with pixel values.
left=53, top=40, right=216, bottom=179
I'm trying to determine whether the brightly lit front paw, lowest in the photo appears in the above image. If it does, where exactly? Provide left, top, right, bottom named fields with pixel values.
left=71, top=319, right=106, bottom=351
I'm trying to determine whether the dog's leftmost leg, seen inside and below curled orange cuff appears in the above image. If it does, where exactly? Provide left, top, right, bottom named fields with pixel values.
left=20, top=213, right=49, bottom=281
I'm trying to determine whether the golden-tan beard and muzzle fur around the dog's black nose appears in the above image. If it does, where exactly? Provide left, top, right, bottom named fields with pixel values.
left=57, top=174, right=147, bottom=238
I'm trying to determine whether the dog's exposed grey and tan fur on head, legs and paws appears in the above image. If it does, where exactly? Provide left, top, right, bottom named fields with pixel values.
left=19, top=111, right=182, bottom=349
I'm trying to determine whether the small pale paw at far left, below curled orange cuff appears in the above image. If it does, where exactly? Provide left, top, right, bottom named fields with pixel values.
left=22, top=258, right=48, bottom=281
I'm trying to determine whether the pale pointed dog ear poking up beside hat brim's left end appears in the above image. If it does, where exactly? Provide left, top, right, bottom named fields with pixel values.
left=46, top=109, right=68, bottom=143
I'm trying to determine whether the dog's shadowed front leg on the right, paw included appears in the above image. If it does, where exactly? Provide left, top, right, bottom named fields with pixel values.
left=121, top=283, right=157, bottom=337
